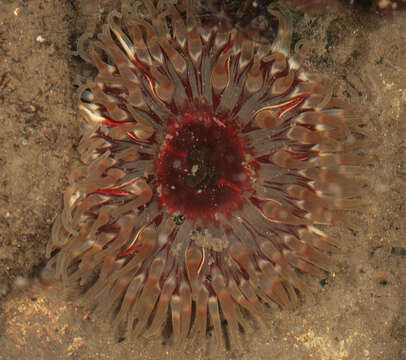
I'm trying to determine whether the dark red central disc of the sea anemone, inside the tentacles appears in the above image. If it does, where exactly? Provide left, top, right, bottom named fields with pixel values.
left=156, top=113, right=249, bottom=220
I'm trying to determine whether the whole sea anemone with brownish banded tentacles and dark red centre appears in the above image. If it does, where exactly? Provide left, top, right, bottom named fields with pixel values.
left=47, top=0, right=363, bottom=345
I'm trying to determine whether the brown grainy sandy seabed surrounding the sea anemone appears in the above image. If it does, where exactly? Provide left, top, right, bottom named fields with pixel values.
left=0, top=0, right=406, bottom=360
